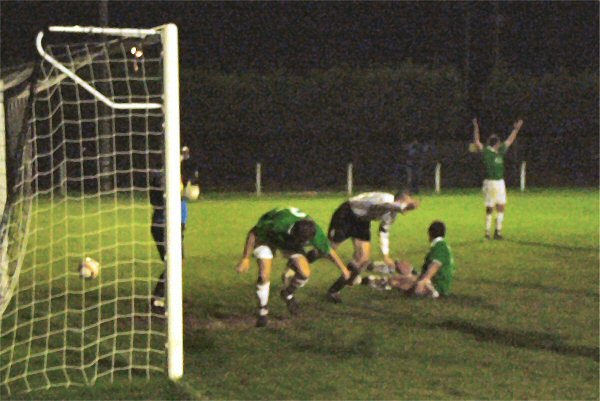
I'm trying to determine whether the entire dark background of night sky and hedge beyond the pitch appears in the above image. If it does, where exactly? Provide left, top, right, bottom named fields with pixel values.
left=1, top=1, right=599, bottom=190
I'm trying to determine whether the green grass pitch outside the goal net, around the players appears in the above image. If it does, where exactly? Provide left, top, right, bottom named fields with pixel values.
left=5, top=190, right=599, bottom=400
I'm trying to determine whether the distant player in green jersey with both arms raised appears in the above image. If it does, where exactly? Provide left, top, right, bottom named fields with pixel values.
left=473, top=118, right=523, bottom=239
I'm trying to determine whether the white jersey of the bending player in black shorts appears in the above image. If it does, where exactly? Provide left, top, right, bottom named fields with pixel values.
left=348, top=192, right=402, bottom=255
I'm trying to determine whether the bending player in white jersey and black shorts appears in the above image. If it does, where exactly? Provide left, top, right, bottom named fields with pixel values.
left=327, top=191, right=419, bottom=303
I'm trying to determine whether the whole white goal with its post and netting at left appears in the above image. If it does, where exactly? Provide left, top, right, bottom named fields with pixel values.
left=0, top=24, right=183, bottom=396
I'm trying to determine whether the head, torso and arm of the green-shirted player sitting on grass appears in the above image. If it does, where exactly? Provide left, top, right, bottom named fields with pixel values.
left=414, top=221, right=456, bottom=296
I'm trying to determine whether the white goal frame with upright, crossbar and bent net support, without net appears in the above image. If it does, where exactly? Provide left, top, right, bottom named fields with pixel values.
left=36, top=24, right=183, bottom=380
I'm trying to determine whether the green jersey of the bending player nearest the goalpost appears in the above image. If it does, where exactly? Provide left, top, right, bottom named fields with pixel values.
left=254, top=207, right=331, bottom=255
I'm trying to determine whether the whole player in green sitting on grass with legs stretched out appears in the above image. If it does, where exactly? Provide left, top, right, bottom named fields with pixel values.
left=363, top=221, right=456, bottom=298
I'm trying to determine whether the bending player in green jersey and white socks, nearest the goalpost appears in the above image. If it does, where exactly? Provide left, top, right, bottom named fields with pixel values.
left=237, top=207, right=350, bottom=327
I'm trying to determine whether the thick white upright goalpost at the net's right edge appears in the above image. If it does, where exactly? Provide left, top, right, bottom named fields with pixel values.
left=161, top=24, right=183, bottom=380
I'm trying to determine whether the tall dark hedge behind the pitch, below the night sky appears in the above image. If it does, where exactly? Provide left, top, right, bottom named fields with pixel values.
left=181, top=63, right=599, bottom=190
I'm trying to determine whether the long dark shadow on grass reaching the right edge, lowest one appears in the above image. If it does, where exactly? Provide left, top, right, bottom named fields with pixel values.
left=430, top=320, right=600, bottom=362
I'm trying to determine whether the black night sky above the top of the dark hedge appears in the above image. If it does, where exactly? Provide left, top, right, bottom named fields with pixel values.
left=1, top=1, right=599, bottom=74
